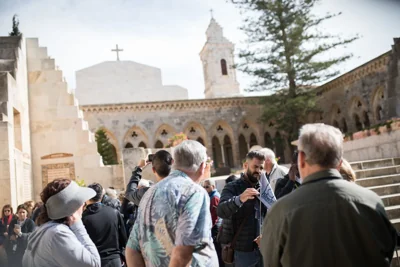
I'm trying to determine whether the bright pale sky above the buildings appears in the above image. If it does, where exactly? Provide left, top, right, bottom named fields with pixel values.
left=0, top=0, right=400, bottom=99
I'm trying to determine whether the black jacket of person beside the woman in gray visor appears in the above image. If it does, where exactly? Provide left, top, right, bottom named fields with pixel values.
left=82, top=203, right=127, bottom=262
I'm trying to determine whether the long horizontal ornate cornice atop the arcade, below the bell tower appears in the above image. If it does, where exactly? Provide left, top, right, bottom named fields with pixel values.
left=80, top=97, right=260, bottom=113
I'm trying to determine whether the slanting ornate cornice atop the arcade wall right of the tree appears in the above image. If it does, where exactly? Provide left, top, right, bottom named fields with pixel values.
left=317, top=51, right=392, bottom=95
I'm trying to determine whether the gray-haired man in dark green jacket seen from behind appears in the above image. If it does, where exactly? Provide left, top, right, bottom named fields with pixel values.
left=260, top=124, right=396, bottom=267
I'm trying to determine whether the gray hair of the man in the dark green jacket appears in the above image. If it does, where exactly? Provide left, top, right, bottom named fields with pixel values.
left=298, top=123, right=343, bottom=168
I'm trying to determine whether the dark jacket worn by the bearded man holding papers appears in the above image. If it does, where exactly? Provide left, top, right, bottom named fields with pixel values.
left=217, top=174, right=266, bottom=252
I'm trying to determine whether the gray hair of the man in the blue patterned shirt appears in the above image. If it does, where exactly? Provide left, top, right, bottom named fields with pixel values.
left=174, top=140, right=207, bottom=175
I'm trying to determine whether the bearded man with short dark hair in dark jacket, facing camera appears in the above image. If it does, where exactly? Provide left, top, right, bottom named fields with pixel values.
left=217, top=151, right=266, bottom=267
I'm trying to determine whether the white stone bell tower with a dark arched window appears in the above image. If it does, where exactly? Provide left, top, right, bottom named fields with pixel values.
left=200, top=19, right=240, bottom=98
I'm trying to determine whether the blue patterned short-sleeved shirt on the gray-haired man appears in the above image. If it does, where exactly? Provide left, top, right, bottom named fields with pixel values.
left=127, top=171, right=218, bottom=267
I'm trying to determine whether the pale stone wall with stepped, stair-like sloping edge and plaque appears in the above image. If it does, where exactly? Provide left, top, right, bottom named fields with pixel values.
left=27, top=38, right=125, bottom=199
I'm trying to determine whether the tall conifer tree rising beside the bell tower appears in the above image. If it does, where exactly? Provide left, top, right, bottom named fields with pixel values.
left=231, top=0, right=358, bottom=147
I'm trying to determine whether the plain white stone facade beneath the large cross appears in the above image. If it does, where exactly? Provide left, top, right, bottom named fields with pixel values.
left=76, top=61, right=188, bottom=105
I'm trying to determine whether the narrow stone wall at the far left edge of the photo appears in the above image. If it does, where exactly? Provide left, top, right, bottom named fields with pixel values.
left=0, top=37, right=32, bottom=207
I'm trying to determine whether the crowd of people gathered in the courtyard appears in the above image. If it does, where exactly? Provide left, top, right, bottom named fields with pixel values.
left=0, top=124, right=397, bottom=267
